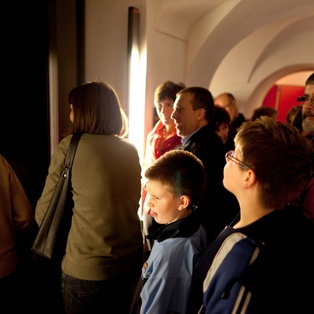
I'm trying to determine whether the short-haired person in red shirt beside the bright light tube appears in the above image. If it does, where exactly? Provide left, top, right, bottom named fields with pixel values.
left=141, top=81, right=185, bottom=254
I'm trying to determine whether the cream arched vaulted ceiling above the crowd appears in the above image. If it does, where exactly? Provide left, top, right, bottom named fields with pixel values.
left=155, top=0, right=314, bottom=115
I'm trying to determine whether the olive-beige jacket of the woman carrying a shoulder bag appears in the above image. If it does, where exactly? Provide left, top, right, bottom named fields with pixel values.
left=35, top=134, right=143, bottom=280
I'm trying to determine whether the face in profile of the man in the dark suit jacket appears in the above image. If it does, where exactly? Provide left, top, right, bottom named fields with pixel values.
left=171, top=93, right=204, bottom=138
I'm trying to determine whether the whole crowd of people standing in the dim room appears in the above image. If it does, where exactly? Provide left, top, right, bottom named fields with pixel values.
left=0, top=73, right=314, bottom=314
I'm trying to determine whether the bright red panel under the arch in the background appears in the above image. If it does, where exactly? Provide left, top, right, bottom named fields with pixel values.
left=263, top=85, right=304, bottom=122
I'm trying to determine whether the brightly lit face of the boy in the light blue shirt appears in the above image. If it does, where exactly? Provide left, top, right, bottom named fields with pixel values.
left=146, top=180, right=188, bottom=224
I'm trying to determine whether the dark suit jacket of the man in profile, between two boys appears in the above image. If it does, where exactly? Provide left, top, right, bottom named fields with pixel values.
left=176, top=123, right=239, bottom=242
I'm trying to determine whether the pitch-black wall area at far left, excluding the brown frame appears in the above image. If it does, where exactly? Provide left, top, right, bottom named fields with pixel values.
left=0, top=1, right=50, bottom=206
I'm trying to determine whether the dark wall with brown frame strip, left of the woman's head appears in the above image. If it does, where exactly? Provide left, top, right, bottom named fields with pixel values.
left=0, top=0, right=84, bottom=204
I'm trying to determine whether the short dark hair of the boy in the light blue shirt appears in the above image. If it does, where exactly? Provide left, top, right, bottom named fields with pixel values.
left=145, top=150, right=206, bottom=205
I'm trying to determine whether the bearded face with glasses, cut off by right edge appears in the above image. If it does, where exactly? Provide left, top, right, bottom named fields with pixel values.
left=302, top=84, right=314, bottom=133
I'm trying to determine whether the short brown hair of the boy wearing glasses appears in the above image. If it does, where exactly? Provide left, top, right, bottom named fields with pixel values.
left=235, top=116, right=311, bottom=209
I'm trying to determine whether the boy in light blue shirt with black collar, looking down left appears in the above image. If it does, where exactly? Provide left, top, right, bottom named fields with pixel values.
left=130, top=150, right=208, bottom=314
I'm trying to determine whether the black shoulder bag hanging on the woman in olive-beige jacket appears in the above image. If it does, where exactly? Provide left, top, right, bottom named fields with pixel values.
left=31, top=134, right=82, bottom=261
